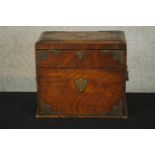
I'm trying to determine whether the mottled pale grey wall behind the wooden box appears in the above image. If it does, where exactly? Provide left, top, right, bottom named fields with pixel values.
left=0, top=26, right=155, bottom=92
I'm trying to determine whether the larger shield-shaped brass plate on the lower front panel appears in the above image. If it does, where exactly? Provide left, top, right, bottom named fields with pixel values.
left=75, top=78, right=88, bottom=92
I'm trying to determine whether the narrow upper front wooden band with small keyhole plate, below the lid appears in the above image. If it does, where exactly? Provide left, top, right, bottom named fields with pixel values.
left=37, top=50, right=126, bottom=67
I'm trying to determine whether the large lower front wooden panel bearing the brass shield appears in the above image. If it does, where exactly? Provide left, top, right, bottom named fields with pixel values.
left=38, top=67, right=125, bottom=115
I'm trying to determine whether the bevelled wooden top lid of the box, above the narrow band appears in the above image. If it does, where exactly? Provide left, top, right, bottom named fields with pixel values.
left=36, top=31, right=126, bottom=49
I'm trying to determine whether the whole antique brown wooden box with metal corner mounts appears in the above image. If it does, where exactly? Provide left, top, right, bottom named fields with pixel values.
left=35, top=31, right=127, bottom=118
